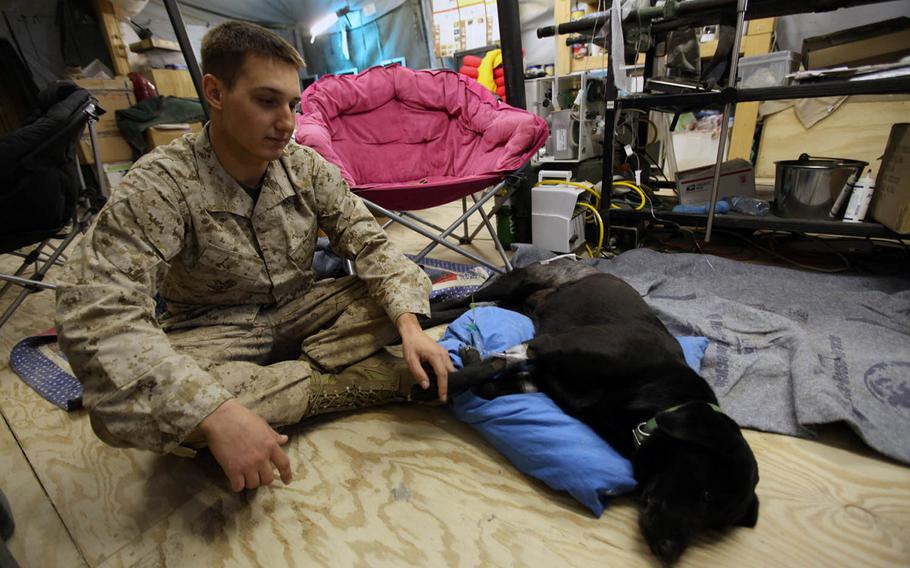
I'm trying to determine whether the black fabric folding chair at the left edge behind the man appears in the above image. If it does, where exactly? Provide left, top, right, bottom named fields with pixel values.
left=0, top=81, right=105, bottom=327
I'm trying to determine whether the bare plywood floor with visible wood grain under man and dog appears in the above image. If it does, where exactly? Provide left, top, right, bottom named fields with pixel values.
left=0, top=202, right=910, bottom=568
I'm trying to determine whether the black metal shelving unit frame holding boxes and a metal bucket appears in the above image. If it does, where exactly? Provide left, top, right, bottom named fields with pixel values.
left=537, top=0, right=910, bottom=242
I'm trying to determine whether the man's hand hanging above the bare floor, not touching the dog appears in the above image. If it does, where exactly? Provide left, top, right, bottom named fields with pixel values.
left=199, top=399, right=292, bottom=491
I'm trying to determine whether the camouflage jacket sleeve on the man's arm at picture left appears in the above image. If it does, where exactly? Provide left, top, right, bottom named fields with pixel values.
left=56, top=164, right=231, bottom=453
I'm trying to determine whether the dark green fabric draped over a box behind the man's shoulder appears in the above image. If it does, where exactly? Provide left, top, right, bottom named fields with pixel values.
left=116, top=97, right=206, bottom=158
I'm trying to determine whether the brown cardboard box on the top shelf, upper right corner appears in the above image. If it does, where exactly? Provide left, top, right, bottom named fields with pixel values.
left=803, top=18, right=910, bottom=69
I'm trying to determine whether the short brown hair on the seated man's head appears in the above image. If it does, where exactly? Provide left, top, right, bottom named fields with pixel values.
left=202, top=21, right=306, bottom=88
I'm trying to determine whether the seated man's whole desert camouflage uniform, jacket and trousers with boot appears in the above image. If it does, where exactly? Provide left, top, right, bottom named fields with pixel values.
left=57, top=126, right=430, bottom=452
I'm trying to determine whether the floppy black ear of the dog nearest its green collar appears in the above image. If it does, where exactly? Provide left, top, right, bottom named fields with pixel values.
left=657, top=403, right=742, bottom=453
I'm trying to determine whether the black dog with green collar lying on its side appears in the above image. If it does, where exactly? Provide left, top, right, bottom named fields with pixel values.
left=420, top=260, right=758, bottom=562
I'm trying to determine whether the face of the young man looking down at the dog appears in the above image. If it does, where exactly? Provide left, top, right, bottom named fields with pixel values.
left=212, top=54, right=300, bottom=161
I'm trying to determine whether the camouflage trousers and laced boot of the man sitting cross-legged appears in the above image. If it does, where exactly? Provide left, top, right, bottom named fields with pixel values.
left=167, top=276, right=412, bottom=448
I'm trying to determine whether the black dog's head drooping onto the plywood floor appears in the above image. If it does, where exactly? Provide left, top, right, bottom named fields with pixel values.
left=635, top=403, right=758, bottom=563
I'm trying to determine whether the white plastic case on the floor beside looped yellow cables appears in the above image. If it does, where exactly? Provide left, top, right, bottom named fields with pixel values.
left=531, top=185, right=585, bottom=252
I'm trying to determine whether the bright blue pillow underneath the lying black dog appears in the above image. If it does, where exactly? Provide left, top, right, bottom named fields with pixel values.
left=440, top=306, right=708, bottom=517
